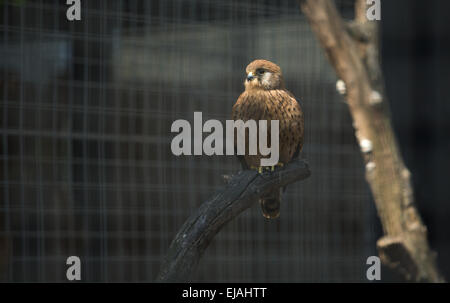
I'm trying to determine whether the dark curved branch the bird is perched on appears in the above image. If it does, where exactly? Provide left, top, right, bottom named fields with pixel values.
left=156, top=159, right=311, bottom=282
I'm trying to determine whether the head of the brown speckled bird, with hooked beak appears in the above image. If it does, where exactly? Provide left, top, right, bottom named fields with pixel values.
left=244, top=60, right=284, bottom=90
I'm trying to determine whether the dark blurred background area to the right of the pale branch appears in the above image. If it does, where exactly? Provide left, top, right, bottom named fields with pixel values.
left=381, top=0, right=450, bottom=281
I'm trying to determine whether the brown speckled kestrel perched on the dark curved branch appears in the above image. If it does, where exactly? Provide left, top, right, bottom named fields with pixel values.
left=231, top=59, right=304, bottom=219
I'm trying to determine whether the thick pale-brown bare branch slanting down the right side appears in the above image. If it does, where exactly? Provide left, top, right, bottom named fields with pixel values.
left=300, top=0, right=443, bottom=282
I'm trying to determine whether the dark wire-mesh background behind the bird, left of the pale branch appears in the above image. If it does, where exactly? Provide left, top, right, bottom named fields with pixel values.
left=0, top=0, right=450, bottom=282
